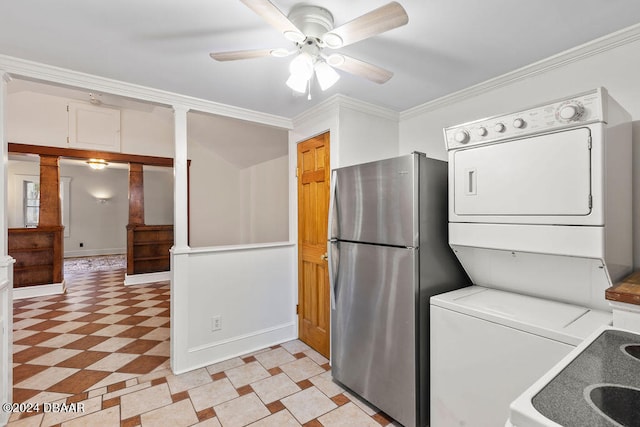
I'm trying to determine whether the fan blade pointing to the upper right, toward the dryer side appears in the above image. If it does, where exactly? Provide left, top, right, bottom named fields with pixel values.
left=322, top=1, right=409, bottom=49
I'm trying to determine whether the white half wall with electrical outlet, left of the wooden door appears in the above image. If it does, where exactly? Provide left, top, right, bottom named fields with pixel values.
left=182, top=245, right=297, bottom=365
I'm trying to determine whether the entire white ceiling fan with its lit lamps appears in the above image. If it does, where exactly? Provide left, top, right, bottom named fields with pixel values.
left=210, top=0, right=409, bottom=98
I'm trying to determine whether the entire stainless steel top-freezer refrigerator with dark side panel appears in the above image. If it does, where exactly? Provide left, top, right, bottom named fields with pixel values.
left=328, top=153, right=469, bottom=427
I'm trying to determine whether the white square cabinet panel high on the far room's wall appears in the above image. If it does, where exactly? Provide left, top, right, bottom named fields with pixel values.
left=69, top=102, right=120, bottom=152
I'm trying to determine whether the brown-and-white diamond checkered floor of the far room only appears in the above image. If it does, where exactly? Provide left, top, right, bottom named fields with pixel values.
left=13, top=270, right=170, bottom=403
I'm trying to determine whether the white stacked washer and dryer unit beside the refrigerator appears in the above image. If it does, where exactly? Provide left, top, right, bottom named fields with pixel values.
left=430, top=88, right=632, bottom=427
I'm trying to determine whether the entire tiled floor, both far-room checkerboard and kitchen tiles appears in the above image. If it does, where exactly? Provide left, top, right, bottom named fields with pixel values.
left=8, top=270, right=399, bottom=427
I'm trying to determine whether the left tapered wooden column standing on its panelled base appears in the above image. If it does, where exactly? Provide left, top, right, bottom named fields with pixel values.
left=38, top=155, right=62, bottom=227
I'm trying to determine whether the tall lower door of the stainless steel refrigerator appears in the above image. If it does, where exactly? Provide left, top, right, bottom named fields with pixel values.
left=331, top=242, right=418, bottom=426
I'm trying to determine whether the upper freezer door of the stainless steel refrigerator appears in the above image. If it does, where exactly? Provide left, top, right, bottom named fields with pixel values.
left=329, top=154, right=424, bottom=246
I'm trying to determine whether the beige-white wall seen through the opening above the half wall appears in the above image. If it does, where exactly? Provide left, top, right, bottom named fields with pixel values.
left=187, top=114, right=289, bottom=247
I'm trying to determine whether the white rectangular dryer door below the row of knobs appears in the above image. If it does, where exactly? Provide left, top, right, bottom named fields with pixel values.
left=453, top=128, right=591, bottom=217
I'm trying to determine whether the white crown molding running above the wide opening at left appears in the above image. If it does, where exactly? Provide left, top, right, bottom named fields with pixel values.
left=0, top=55, right=293, bottom=129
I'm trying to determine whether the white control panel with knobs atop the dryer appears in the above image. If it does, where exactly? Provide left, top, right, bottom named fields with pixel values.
left=444, top=89, right=606, bottom=150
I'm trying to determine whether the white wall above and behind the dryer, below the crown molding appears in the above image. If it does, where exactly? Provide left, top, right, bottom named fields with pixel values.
left=400, top=37, right=640, bottom=267
